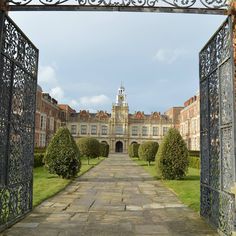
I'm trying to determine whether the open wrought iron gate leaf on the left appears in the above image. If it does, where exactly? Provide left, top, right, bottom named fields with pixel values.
left=0, top=12, right=38, bottom=231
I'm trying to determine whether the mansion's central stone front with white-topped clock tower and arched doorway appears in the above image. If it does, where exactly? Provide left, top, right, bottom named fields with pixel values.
left=67, top=86, right=174, bottom=153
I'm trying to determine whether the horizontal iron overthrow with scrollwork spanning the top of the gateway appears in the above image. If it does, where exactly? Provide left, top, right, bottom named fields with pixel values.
left=5, top=0, right=229, bottom=14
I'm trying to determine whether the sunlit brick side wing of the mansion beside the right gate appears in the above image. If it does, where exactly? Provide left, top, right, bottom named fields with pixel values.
left=179, top=94, right=200, bottom=151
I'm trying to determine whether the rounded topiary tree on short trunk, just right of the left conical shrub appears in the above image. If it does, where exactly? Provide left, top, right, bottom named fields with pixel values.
left=77, top=137, right=100, bottom=164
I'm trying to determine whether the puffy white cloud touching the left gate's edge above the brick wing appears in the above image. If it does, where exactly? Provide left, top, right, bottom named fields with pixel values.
left=39, top=65, right=58, bottom=86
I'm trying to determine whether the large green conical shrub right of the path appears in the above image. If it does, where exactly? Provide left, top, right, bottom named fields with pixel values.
left=156, top=128, right=189, bottom=179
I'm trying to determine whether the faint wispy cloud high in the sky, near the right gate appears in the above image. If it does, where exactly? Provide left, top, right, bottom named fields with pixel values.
left=154, top=48, right=188, bottom=64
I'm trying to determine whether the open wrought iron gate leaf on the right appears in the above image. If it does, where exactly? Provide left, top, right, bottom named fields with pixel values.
left=200, top=17, right=236, bottom=235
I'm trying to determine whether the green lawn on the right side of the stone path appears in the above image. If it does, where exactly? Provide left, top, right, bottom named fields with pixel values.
left=132, top=158, right=200, bottom=212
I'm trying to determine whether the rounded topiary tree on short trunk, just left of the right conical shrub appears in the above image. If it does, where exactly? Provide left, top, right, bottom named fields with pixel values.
left=138, top=141, right=159, bottom=165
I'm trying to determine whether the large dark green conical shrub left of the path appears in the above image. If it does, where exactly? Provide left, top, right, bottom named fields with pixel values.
left=44, top=128, right=81, bottom=179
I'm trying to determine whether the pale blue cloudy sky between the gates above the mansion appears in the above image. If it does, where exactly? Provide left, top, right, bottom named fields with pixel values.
left=9, top=12, right=226, bottom=113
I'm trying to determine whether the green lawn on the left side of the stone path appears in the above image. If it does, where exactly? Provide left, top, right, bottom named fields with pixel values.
left=33, top=158, right=104, bottom=206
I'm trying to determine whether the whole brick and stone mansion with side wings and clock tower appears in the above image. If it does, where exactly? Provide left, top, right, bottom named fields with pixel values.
left=35, top=86, right=200, bottom=152
